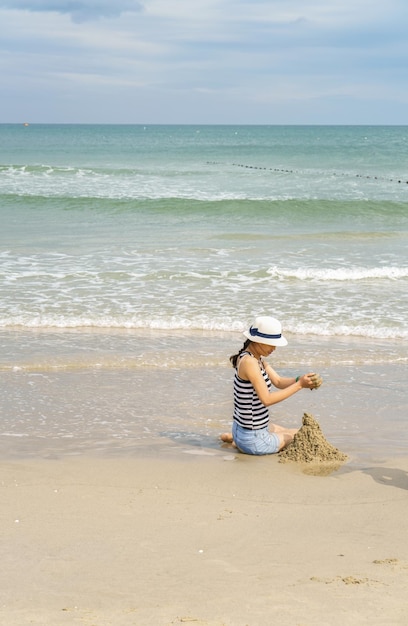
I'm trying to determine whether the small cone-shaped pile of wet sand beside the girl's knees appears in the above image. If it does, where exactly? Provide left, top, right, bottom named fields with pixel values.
left=279, top=413, right=347, bottom=465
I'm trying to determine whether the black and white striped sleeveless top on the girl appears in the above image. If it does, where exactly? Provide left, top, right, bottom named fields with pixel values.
left=234, top=351, right=272, bottom=430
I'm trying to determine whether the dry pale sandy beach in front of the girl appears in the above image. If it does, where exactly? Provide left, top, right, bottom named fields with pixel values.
left=0, top=448, right=408, bottom=626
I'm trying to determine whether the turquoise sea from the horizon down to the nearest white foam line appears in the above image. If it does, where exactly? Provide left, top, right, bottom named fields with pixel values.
left=0, top=125, right=408, bottom=338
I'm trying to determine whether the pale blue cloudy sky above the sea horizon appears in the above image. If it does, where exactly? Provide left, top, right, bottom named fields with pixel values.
left=0, top=0, right=408, bottom=125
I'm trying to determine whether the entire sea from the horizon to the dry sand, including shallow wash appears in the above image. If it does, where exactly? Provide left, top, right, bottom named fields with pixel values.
left=0, top=123, right=408, bottom=463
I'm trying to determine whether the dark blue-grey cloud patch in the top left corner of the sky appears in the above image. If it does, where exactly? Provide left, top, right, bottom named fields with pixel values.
left=0, top=0, right=143, bottom=23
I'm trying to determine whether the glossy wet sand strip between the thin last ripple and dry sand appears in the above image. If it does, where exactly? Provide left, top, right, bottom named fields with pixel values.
left=0, top=356, right=408, bottom=464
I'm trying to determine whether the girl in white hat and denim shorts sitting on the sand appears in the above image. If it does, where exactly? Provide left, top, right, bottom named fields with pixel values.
left=221, top=317, right=322, bottom=455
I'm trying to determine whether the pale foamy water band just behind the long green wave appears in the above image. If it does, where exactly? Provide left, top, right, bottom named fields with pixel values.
left=0, top=160, right=408, bottom=201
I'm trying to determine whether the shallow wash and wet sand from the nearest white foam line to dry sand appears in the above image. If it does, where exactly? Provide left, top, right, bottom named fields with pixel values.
left=0, top=330, right=408, bottom=466
